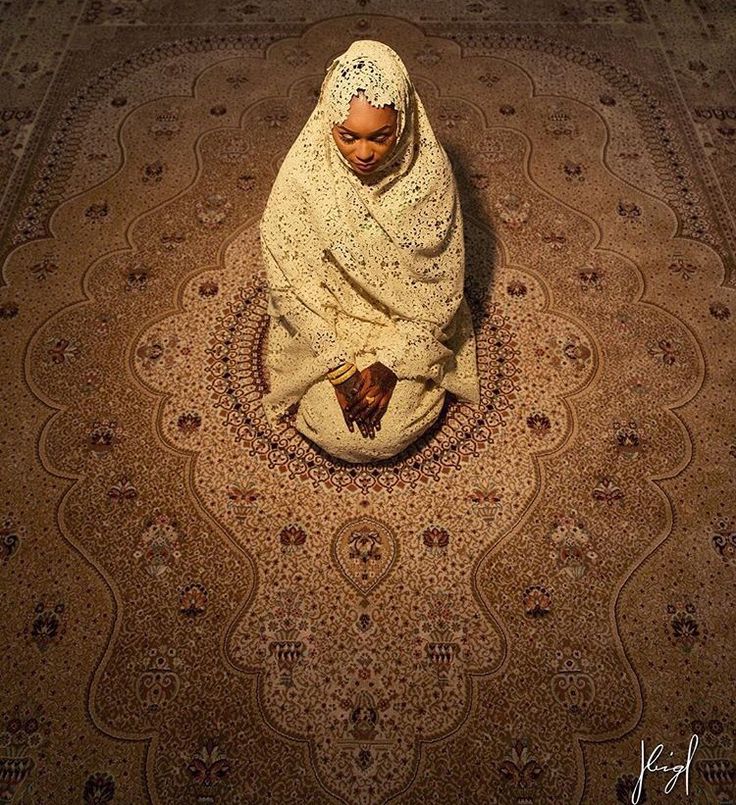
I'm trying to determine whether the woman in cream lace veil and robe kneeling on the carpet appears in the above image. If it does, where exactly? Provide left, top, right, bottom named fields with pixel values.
left=260, top=39, right=480, bottom=462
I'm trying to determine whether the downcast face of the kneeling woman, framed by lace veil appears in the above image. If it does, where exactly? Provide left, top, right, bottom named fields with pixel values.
left=332, top=95, right=397, bottom=176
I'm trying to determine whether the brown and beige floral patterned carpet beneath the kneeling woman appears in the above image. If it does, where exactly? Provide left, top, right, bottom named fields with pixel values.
left=0, top=0, right=736, bottom=805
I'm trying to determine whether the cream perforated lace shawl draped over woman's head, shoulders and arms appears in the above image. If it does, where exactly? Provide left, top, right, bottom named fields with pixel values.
left=260, top=40, right=480, bottom=428
